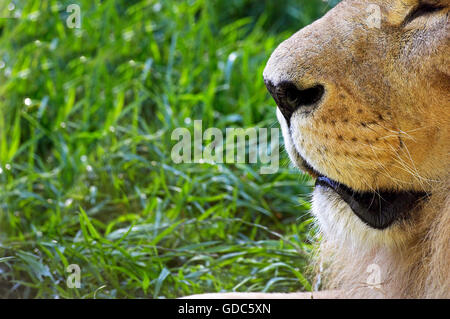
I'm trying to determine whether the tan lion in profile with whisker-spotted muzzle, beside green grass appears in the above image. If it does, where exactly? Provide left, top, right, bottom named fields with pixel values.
left=187, top=0, right=450, bottom=298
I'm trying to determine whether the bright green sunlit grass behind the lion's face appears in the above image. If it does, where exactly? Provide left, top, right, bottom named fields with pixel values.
left=0, top=0, right=338, bottom=298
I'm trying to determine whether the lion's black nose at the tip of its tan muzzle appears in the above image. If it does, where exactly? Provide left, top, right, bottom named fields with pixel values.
left=264, top=81, right=325, bottom=125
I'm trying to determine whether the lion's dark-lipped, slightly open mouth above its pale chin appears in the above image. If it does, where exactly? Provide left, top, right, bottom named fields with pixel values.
left=303, top=161, right=429, bottom=229
